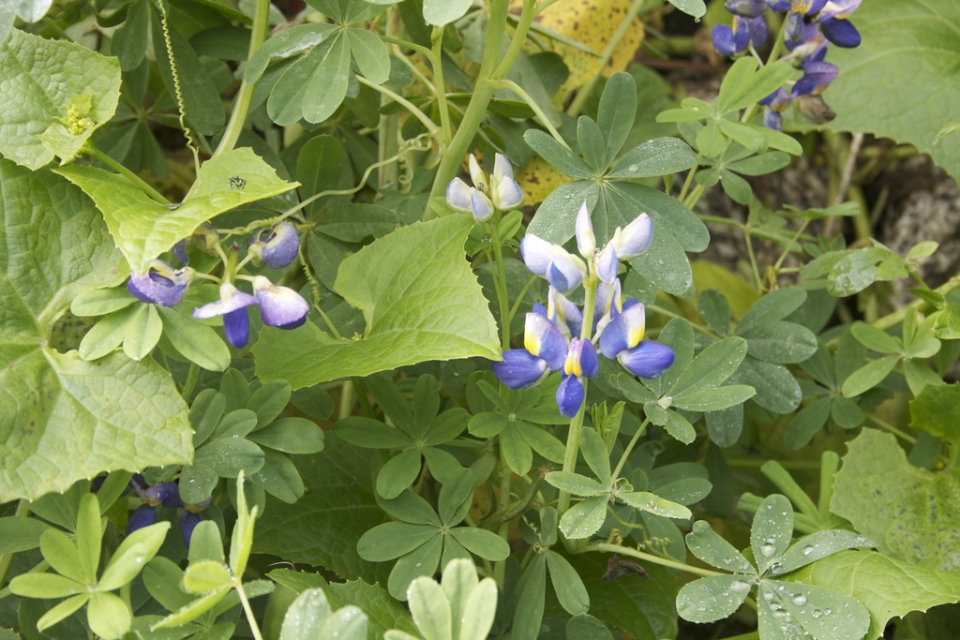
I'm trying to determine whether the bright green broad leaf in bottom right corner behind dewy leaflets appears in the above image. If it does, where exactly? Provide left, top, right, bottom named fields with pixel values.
left=791, top=551, right=960, bottom=640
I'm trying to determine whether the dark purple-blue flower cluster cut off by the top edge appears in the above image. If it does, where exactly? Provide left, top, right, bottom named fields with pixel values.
left=712, top=0, right=863, bottom=131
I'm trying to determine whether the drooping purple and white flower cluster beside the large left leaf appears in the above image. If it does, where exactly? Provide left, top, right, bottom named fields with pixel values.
left=127, top=222, right=310, bottom=348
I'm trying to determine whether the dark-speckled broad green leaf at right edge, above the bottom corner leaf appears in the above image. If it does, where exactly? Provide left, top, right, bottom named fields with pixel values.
left=830, top=428, right=960, bottom=571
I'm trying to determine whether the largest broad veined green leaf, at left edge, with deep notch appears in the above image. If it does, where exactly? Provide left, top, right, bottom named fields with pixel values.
left=0, top=160, right=192, bottom=502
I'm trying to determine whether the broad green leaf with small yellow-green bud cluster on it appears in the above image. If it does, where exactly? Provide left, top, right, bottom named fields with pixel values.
left=0, top=29, right=120, bottom=170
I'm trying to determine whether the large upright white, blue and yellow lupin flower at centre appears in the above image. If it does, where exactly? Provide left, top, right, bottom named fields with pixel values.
left=493, top=203, right=674, bottom=417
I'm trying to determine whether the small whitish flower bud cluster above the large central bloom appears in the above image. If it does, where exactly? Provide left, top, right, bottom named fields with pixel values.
left=447, top=153, right=523, bottom=222
